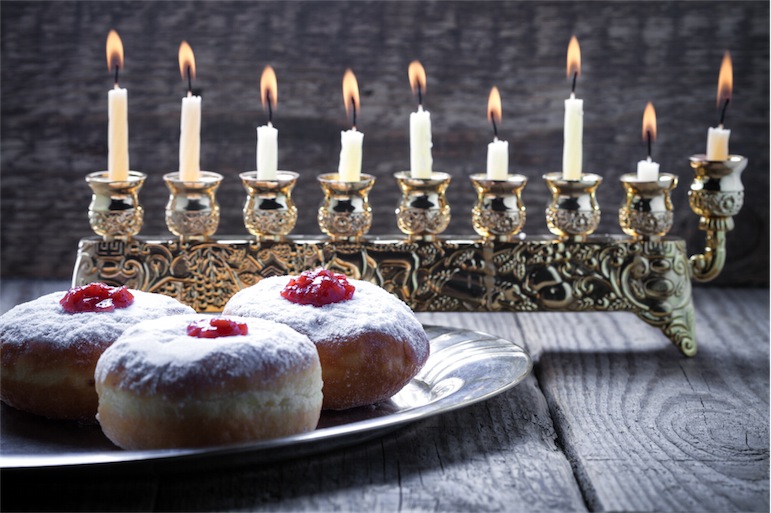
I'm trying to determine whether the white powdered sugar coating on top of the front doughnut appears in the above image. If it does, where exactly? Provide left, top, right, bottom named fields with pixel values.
left=95, top=314, right=318, bottom=396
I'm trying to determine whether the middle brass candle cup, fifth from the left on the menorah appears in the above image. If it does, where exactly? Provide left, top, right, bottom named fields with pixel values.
left=394, top=171, right=452, bottom=241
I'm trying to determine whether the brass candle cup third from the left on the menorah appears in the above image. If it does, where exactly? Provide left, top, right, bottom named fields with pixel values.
left=239, top=171, right=300, bottom=240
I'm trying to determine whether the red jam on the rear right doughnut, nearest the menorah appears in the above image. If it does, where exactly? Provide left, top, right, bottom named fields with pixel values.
left=281, top=269, right=356, bottom=306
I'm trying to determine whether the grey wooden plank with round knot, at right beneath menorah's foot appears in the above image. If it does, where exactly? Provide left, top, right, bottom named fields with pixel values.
left=518, top=289, right=769, bottom=511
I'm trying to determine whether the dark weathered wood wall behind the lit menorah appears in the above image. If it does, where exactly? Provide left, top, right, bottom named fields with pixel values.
left=0, top=1, right=769, bottom=286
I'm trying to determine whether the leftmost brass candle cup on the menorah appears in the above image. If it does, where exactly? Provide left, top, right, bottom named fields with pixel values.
left=86, top=171, right=147, bottom=241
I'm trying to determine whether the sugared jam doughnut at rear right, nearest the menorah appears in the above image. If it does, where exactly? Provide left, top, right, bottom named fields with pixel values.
left=223, top=269, right=429, bottom=410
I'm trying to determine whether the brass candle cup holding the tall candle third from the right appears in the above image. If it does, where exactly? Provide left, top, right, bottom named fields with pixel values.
left=543, top=173, right=602, bottom=242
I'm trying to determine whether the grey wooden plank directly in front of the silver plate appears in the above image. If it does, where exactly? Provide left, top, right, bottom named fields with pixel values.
left=156, top=370, right=585, bottom=512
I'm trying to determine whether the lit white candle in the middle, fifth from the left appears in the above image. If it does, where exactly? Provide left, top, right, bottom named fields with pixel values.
left=407, top=61, right=433, bottom=178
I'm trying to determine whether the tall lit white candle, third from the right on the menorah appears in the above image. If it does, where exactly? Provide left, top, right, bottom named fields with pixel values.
left=562, top=36, right=584, bottom=180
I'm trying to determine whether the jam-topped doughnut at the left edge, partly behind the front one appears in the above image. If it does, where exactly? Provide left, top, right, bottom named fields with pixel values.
left=0, top=283, right=194, bottom=422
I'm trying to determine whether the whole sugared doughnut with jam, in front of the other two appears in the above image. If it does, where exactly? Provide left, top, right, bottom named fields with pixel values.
left=95, top=315, right=322, bottom=450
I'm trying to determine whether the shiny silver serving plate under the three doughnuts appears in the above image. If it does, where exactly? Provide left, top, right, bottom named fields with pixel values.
left=0, top=326, right=533, bottom=469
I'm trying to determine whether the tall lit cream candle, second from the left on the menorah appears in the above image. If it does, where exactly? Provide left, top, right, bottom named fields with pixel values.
left=179, top=41, right=201, bottom=182
